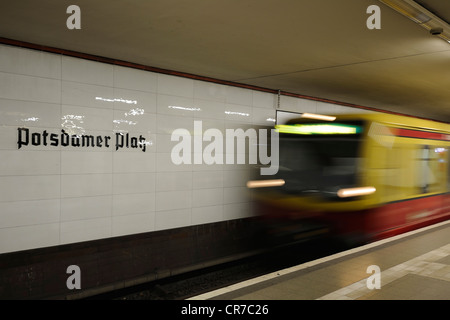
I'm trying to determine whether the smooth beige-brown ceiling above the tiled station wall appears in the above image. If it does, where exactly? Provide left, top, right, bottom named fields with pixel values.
left=0, top=0, right=450, bottom=122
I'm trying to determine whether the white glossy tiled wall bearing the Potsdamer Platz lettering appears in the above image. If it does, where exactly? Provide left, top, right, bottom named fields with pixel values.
left=0, top=45, right=368, bottom=253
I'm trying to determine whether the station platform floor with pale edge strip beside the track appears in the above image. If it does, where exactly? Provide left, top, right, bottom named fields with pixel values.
left=190, top=221, right=450, bottom=301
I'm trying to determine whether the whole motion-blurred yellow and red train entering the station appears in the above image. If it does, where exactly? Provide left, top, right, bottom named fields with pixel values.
left=248, top=113, right=450, bottom=244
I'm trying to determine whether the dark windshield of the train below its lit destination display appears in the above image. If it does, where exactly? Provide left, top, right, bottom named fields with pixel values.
left=277, top=124, right=362, bottom=198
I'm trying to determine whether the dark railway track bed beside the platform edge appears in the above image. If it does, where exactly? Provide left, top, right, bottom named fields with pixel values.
left=86, top=239, right=348, bottom=300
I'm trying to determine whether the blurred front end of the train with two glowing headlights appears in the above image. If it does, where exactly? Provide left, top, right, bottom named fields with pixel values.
left=248, top=116, right=376, bottom=243
